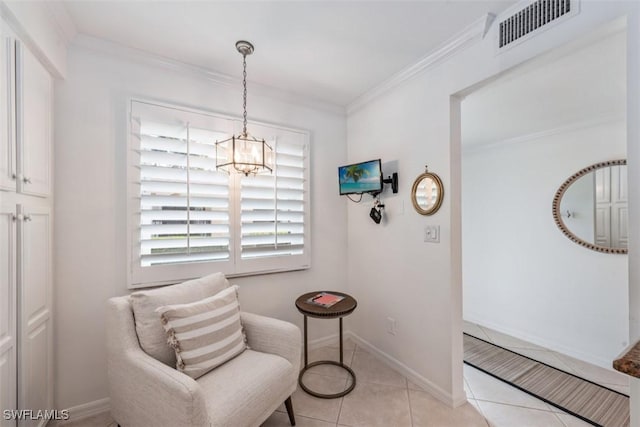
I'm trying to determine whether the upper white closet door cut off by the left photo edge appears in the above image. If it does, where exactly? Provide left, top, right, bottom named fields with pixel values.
left=0, top=20, right=18, bottom=191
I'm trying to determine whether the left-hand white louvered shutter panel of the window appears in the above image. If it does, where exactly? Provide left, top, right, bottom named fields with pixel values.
left=140, top=119, right=230, bottom=267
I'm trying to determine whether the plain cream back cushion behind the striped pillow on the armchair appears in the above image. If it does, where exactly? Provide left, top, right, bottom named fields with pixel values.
left=130, top=273, right=229, bottom=367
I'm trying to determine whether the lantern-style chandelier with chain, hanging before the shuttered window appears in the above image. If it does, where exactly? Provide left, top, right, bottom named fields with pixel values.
left=215, top=40, right=273, bottom=176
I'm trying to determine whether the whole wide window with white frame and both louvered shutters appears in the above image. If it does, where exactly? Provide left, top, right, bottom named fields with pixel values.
left=128, top=101, right=310, bottom=287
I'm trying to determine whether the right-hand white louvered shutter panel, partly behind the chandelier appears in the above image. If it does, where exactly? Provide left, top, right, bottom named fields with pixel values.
left=240, top=138, right=308, bottom=260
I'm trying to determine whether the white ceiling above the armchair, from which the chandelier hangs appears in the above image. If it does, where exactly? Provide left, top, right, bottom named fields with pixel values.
left=63, top=0, right=515, bottom=106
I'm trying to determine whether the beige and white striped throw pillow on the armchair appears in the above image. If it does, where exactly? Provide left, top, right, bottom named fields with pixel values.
left=156, top=286, right=247, bottom=379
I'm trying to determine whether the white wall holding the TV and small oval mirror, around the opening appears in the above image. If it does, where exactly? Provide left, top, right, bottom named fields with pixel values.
left=347, top=2, right=640, bottom=412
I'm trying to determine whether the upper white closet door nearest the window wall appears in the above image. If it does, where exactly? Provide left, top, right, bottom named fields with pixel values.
left=16, top=43, right=53, bottom=197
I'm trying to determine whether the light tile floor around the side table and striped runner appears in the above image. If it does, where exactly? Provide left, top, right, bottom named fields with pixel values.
left=58, top=322, right=629, bottom=427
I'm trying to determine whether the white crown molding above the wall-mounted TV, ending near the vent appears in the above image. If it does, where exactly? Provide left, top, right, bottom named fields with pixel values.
left=347, top=13, right=495, bottom=114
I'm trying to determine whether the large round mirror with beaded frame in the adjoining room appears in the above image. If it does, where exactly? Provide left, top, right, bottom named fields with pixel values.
left=553, top=160, right=628, bottom=254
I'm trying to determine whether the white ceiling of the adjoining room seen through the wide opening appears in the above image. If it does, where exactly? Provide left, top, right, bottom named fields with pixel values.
left=461, top=27, right=627, bottom=150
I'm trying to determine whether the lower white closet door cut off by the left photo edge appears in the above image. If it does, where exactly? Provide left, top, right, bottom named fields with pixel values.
left=0, top=205, right=18, bottom=427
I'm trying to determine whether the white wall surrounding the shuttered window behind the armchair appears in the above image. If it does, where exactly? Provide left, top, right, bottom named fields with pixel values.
left=55, top=41, right=347, bottom=408
